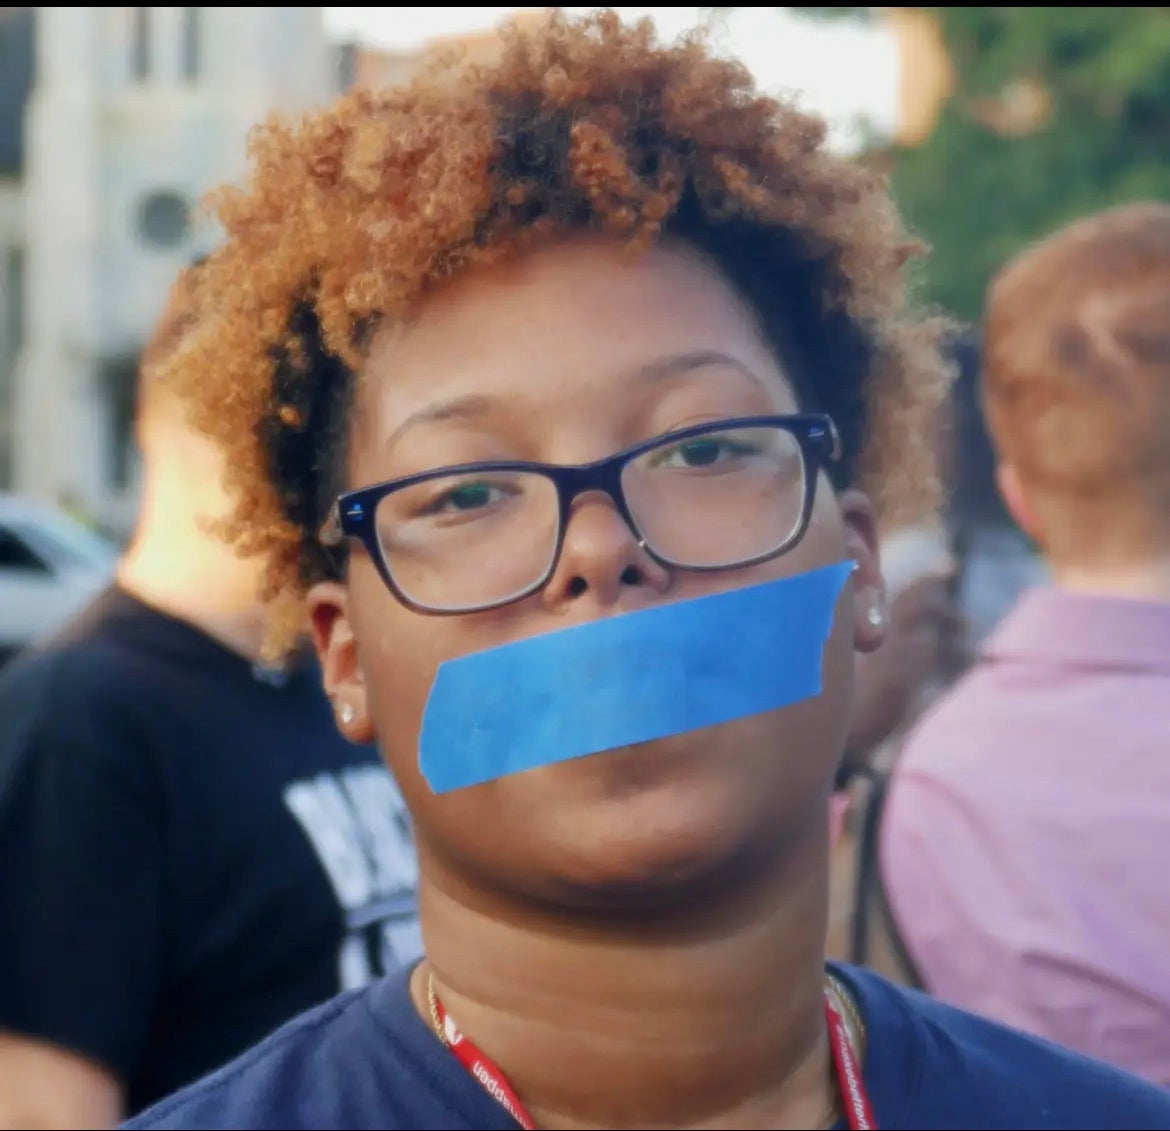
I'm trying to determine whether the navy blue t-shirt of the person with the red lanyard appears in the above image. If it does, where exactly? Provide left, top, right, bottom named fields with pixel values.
left=124, top=966, right=1170, bottom=1131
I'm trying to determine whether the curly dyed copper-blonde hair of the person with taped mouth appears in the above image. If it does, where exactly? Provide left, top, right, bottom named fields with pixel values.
left=170, top=12, right=949, bottom=653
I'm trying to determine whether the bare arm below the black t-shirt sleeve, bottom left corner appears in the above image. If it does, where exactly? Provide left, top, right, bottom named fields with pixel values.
left=0, top=1033, right=124, bottom=1131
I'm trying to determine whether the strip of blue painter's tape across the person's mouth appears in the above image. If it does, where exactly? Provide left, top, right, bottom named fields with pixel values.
left=419, top=563, right=852, bottom=793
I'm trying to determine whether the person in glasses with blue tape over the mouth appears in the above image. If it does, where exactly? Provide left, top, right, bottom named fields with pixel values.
left=116, top=12, right=1170, bottom=1129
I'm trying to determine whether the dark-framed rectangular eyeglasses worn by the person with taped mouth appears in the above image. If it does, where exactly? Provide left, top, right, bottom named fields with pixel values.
left=321, top=414, right=840, bottom=614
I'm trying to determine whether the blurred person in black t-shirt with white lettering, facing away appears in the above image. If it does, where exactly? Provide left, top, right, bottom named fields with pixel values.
left=0, top=267, right=421, bottom=1129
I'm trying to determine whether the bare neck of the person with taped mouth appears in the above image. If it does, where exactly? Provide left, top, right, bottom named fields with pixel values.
left=412, top=829, right=838, bottom=1127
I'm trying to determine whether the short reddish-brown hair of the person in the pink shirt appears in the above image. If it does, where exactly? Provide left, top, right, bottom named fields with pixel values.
left=984, top=201, right=1170, bottom=595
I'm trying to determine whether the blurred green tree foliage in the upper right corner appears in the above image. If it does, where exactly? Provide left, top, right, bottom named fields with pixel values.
left=796, top=7, right=1170, bottom=319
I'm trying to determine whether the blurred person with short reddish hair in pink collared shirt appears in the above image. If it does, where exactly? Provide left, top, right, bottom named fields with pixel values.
left=880, top=204, right=1170, bottom=1083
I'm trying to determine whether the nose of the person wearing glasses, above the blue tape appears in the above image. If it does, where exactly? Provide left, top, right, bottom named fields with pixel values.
left=544, top=492, right=672, bottom=608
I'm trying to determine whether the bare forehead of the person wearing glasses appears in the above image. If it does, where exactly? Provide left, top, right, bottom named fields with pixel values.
left=363, top=239, right=785, bottom=430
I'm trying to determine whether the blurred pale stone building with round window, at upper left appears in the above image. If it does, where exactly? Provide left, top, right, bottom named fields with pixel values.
left=0, top=7, right=342, bottom=535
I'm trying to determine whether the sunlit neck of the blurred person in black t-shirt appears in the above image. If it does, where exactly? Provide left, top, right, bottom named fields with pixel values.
left=117, top=503, right=264, bottom=660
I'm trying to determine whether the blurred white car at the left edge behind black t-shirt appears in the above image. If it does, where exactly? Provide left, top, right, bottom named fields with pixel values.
left=0, top=491, right=118, bottom=666
